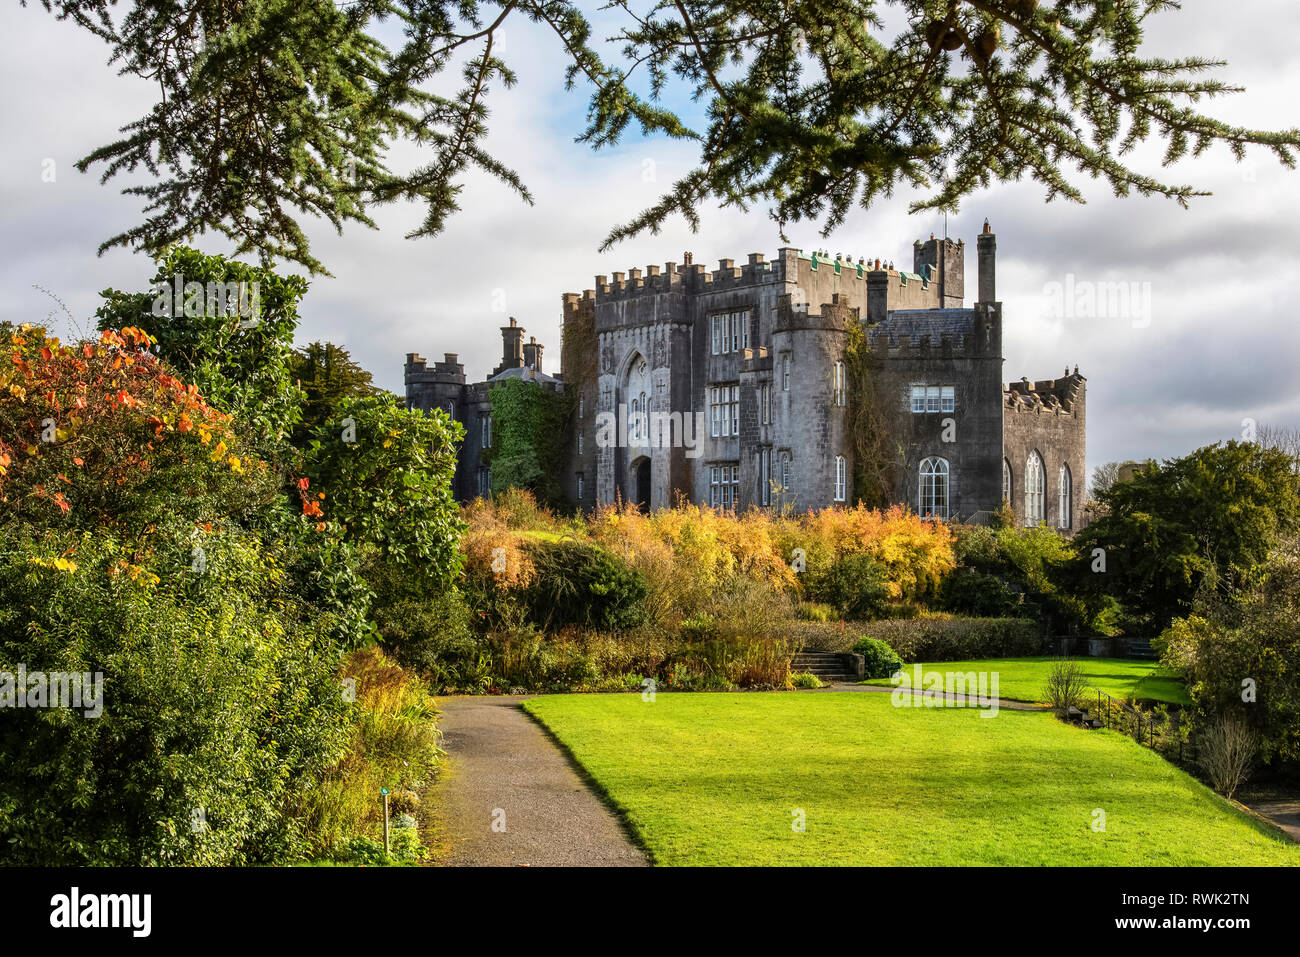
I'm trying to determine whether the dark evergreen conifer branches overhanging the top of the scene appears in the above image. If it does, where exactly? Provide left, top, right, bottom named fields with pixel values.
left=42, top=0, right=1300, bottom=270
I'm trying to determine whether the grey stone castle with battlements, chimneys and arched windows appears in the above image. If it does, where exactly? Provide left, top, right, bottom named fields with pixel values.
left=406, top=221, right=1087, bottom=532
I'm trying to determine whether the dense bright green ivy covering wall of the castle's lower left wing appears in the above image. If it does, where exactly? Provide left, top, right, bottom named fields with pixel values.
left=484, top=378, right=572, bottom=508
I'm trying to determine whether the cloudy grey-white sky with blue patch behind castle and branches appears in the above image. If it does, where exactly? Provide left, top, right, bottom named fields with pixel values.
left=0, top=0, right=1300, bottom=478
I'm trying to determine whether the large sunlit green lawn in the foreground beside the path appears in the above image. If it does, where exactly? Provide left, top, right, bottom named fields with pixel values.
left=524, top=692, right=1300, bottom=865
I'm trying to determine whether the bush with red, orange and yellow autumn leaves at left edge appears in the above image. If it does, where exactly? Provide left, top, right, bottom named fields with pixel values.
left=0, top=319, right=267, bottom=532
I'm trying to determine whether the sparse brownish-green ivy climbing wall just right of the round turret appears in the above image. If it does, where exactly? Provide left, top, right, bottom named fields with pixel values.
left=844, top=321, right=905, bottom=508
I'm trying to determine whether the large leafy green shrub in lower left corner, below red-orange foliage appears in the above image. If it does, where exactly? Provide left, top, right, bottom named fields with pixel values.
left=0, top=527, right=351, bottom=866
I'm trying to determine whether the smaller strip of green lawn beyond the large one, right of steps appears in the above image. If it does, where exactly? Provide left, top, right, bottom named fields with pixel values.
left=863, top=658, right=1190, bottom=705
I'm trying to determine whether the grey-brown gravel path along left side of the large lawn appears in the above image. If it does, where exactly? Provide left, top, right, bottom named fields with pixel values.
left=433, top=696, right=649, bottom=867
